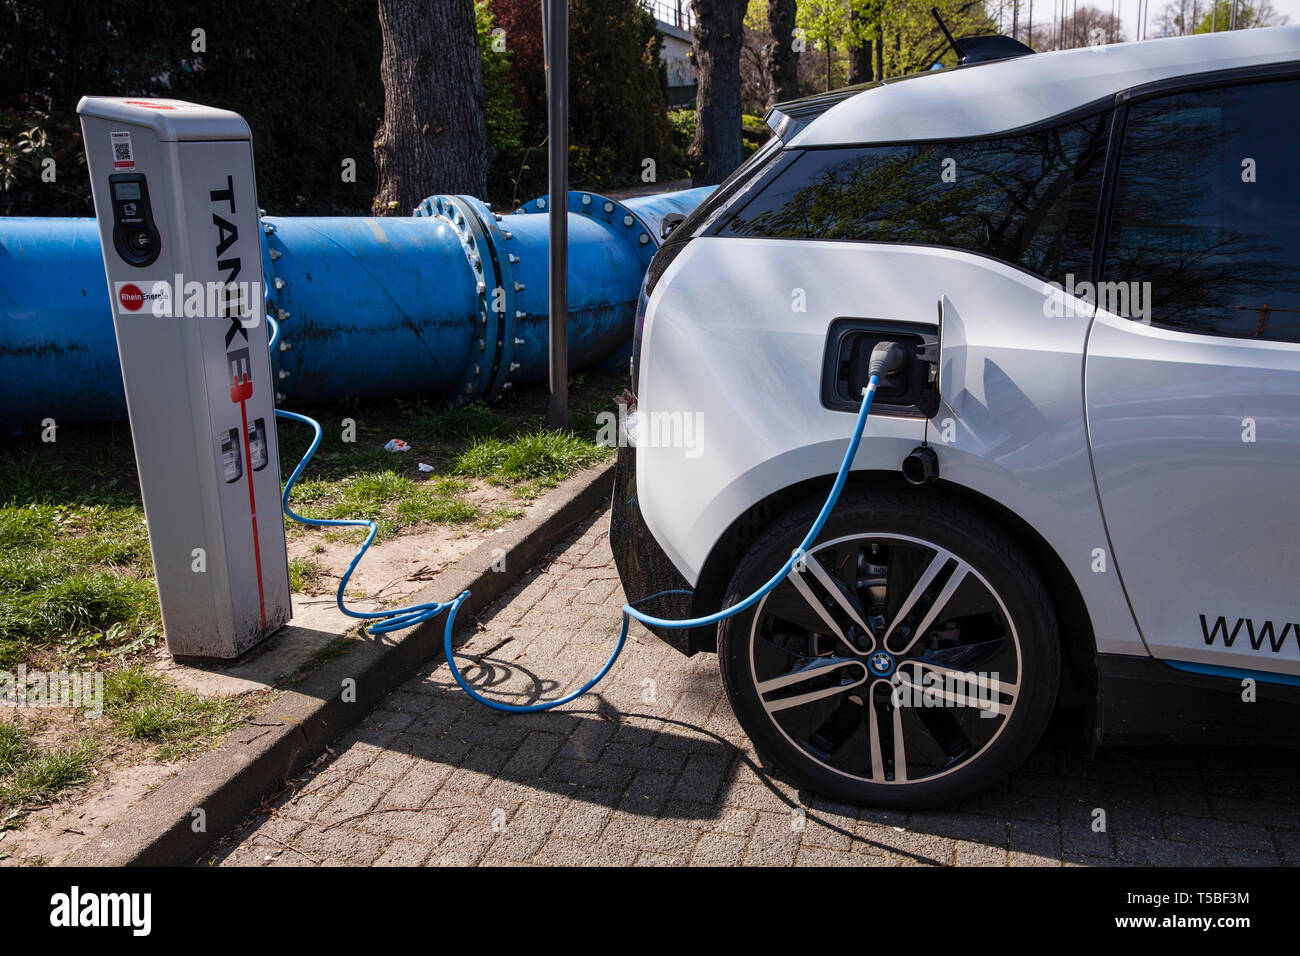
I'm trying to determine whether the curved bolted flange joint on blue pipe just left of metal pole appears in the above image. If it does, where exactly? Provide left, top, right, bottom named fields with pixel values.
left=415, top=195, right=501, bottom=406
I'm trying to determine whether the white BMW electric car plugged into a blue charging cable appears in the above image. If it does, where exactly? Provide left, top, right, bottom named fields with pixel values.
left=611, top=27, right=1300, bottom=806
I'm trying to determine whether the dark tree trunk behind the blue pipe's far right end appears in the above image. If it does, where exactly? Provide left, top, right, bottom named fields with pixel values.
left=686, top=0, right=746, bottom=186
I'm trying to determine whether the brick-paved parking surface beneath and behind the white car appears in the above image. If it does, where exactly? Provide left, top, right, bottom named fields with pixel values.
left=205, top=512, right=1300, bottom=866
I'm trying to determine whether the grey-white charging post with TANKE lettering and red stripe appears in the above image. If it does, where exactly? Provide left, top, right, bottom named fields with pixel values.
left=77, top=96, right=291, bottom=658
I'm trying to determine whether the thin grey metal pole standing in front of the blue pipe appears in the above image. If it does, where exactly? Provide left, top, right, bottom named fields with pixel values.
left=542, top=0, right=568, bottom=428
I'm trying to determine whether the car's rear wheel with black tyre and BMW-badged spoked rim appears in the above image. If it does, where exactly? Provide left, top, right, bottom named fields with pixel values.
left=718, top=489, right=1061, bottom=808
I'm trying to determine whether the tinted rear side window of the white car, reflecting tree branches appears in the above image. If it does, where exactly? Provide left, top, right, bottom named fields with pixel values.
left=722, top=113, right=1110, bottom=282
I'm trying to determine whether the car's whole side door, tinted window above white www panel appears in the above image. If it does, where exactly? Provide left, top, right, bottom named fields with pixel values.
left=1084, top=75, right=1300, bottom=683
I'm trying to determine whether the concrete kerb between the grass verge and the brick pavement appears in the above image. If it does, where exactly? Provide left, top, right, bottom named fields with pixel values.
left=66, top=464, right=616, bottom=866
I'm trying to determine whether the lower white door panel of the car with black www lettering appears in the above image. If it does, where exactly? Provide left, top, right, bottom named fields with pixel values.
left=1087, top=312, right=1300, bottom=675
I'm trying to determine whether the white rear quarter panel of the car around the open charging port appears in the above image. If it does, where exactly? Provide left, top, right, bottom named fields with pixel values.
left=637, top=238, right=1147, bottom=654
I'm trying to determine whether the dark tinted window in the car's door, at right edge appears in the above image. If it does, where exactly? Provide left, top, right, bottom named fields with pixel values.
left=1105, top=79, right=1300, bottom=342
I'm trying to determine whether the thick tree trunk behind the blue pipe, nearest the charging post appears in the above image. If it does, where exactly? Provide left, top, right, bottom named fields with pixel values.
left=373, top=0, right=491, bottom=216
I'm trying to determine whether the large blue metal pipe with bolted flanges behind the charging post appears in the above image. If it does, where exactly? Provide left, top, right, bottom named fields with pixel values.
left=0, top=187, right=711, bottom=428
